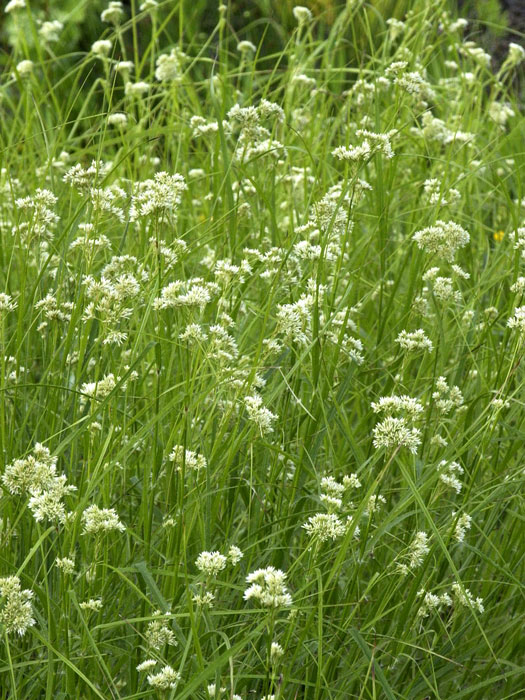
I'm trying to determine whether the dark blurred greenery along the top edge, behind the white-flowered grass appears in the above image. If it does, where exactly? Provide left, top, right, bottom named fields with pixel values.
left=0, top=0, right=525, bottom=61
